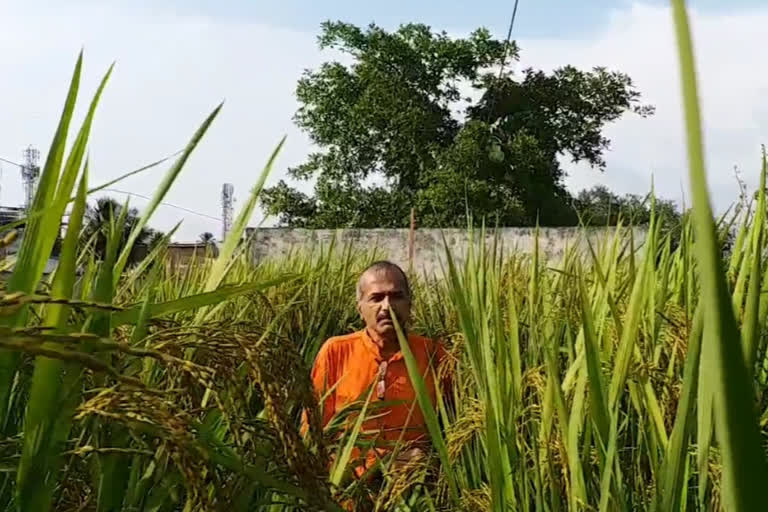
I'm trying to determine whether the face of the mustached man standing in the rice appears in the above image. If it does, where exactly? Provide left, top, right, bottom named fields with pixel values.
left=357, top=271, right=411, bottom=338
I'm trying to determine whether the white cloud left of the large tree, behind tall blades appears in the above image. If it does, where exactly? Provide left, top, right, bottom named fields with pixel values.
left=0, top=1, right=321, bottom=240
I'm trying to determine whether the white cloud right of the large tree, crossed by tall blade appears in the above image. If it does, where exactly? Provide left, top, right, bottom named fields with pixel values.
left=518, top=4, right=768, bottom=210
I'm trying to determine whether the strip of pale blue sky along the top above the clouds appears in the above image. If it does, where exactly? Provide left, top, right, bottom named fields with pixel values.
left=143, top=0, right=764, bottom=38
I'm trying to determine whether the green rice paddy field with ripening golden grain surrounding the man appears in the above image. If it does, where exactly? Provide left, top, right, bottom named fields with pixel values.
left=0, top=1, right=768, bottom=512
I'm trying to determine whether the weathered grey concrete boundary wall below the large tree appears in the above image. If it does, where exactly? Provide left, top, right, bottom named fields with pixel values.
left=247, top=228, right=645, bottom=274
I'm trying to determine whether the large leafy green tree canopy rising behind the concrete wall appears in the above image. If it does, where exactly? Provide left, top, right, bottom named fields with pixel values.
left=262, top=22, right=652, bottom=228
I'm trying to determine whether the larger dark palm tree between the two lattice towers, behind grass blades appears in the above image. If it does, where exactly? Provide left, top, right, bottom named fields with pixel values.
left=82, top=197, right=157, bottom=265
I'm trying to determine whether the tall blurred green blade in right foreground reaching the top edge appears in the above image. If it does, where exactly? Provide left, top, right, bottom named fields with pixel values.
left=672, top=0, right=768, bottom=510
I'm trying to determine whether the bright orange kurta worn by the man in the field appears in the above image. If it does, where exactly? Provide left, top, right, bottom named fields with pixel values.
left=304, top=330, right=444, bottom=476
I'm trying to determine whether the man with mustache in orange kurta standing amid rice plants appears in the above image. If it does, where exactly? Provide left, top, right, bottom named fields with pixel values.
left=304, top=261, right=444, bottom=477
